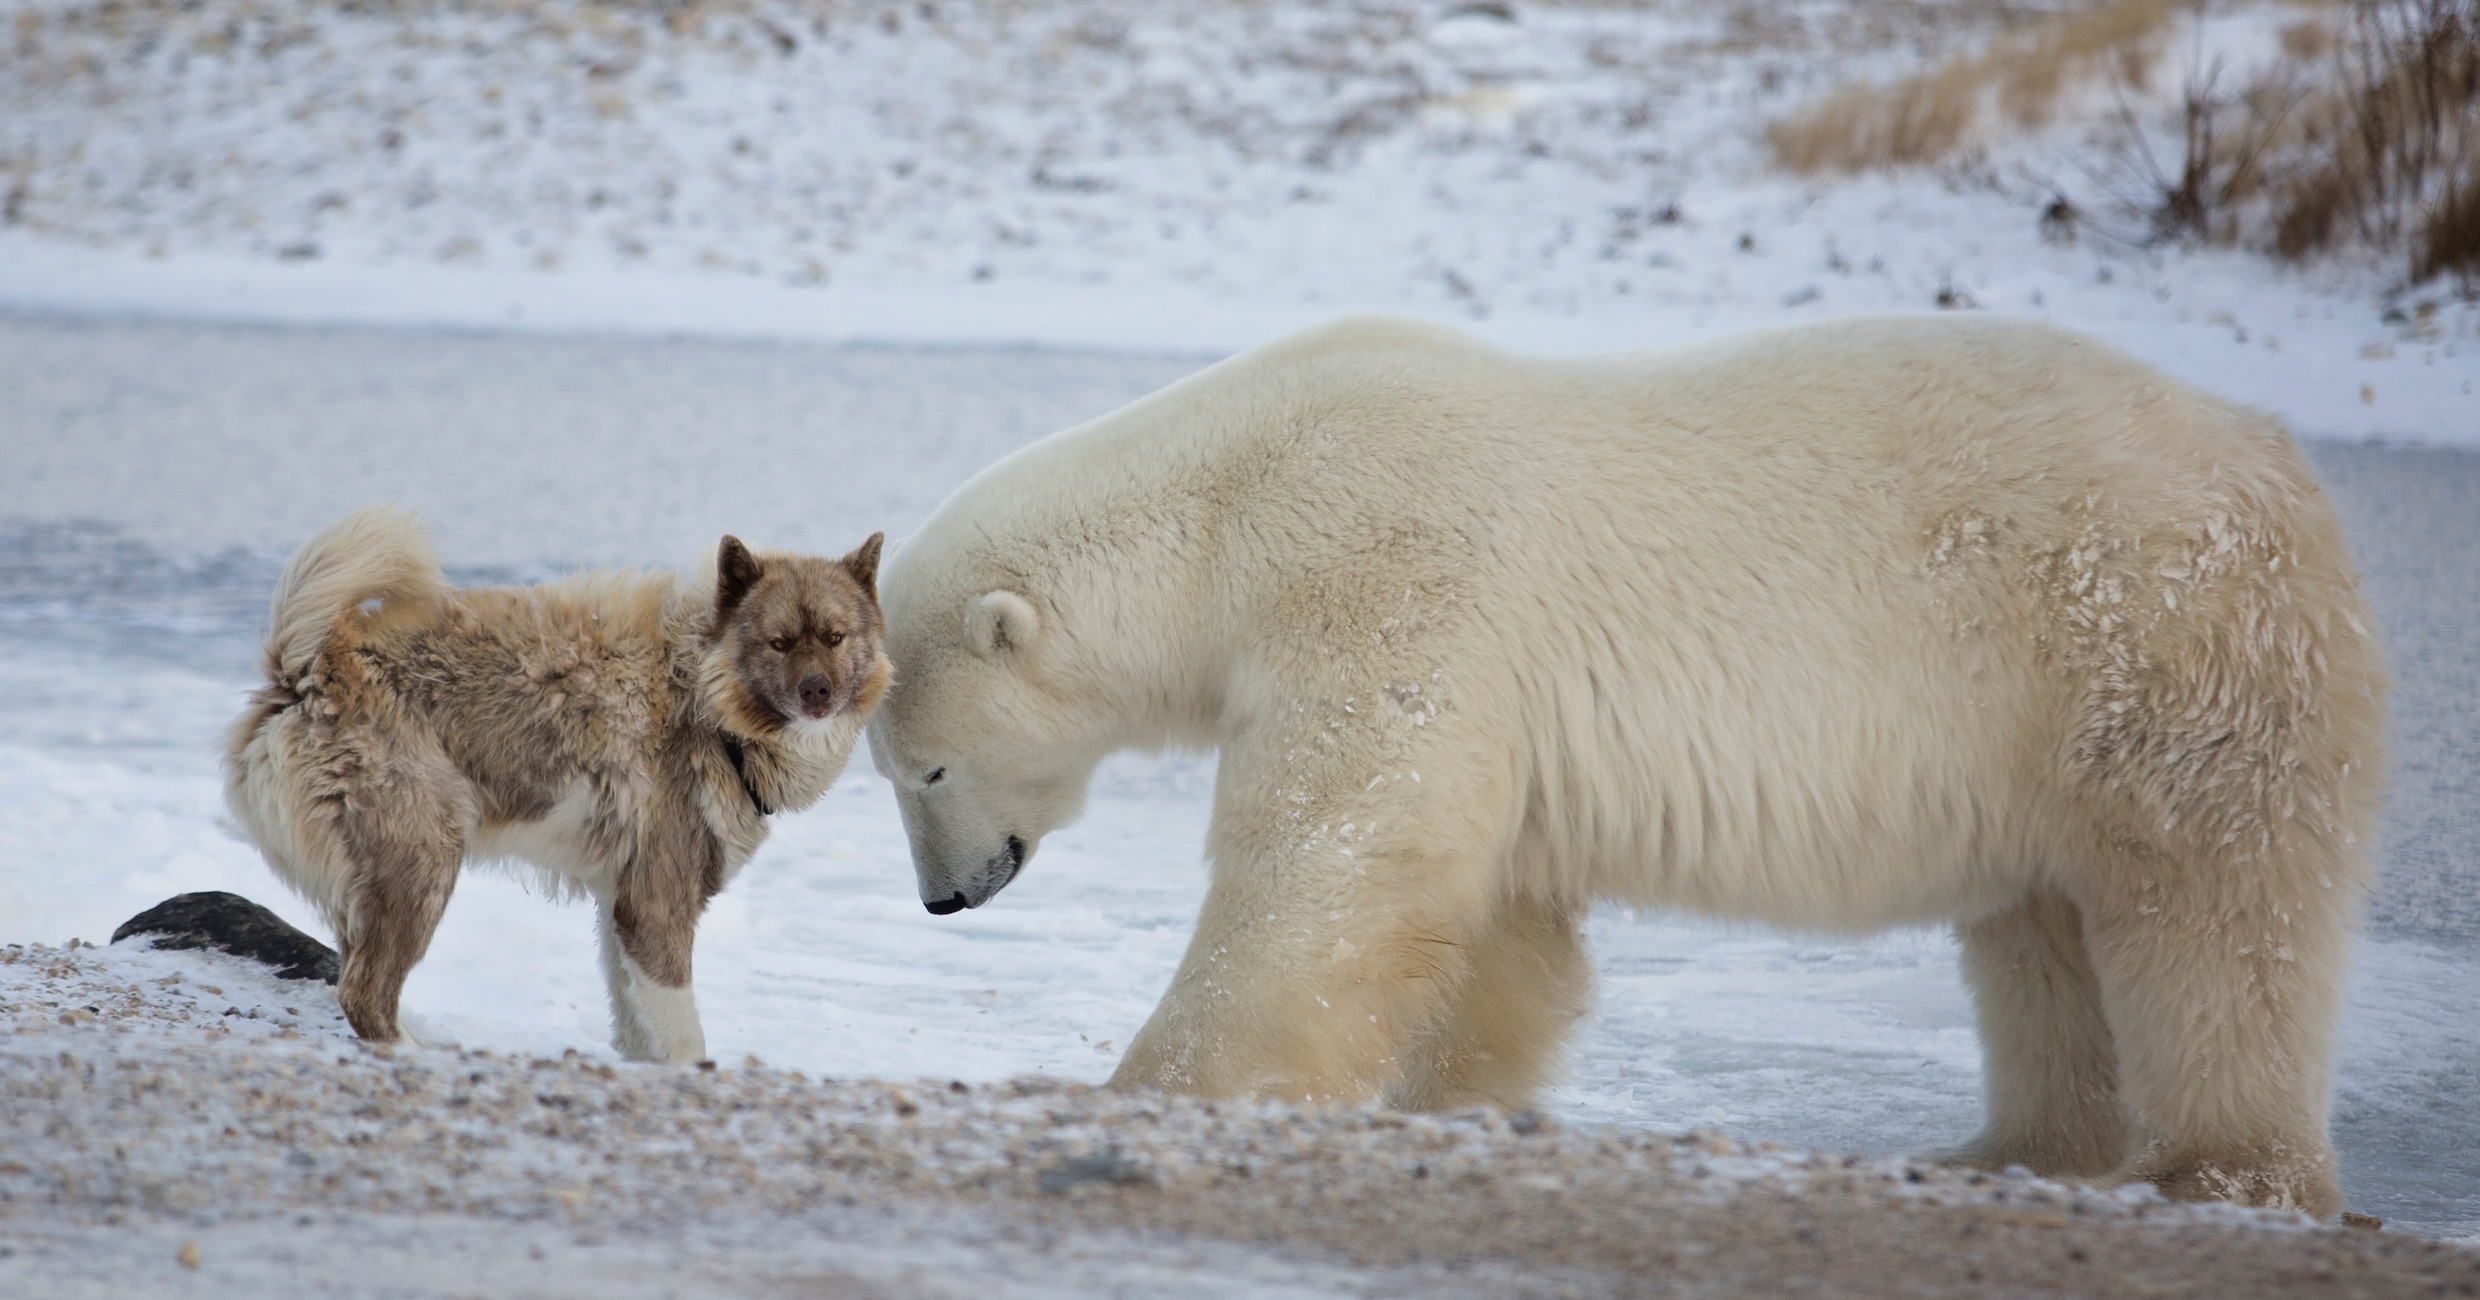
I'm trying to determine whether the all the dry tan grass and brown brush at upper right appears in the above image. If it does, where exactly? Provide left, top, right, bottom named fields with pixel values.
left=1766, top=0, right=2480, bottom=288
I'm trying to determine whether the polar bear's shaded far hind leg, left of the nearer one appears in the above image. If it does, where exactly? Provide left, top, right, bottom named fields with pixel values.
left=1932, top=893, right=2128, bottom=1176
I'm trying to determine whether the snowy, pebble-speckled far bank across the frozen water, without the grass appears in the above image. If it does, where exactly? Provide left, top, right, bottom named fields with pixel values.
left=0, top=0, right=2480, bottom=442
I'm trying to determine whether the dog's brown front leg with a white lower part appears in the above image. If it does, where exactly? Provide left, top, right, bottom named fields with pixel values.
left=603, top=819, right=722, bottom=1062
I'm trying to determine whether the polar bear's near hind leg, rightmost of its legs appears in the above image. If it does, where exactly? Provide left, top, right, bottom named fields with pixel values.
left=2083, top=844, right=2351, bottom=1218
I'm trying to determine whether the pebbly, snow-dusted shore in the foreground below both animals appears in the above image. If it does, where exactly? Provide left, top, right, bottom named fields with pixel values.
left=0, top=945, right=2480, bottom=1295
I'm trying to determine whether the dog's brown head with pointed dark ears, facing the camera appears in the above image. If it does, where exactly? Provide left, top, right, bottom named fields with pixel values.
left=707, top=533, right=888, bottom=737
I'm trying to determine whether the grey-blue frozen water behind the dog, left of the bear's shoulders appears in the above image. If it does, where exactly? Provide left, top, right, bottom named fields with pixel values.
left=0, top=315, right=1203, bottom=570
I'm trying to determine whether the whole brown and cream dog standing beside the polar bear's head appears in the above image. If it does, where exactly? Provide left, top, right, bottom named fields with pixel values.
left=223, top=506, right=888, bottom=1062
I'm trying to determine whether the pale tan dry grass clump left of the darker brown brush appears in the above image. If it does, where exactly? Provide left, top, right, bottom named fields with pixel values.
left=1766, top=0, right=2177, bottom=174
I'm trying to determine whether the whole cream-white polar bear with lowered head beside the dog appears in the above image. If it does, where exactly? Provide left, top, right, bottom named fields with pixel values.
left=870, top=318, right=2386, bottom=1216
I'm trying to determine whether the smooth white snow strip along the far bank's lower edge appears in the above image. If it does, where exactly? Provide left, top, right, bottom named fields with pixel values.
left=0, top=233, right=2480, bottom=447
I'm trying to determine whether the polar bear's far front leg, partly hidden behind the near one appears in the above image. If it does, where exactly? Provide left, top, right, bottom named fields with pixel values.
left=1386, top=898, right=1592, bottom=1111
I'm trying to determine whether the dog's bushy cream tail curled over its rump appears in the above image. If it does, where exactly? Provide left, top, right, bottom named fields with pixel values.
left=268, top=506, right=449, bottom=685
